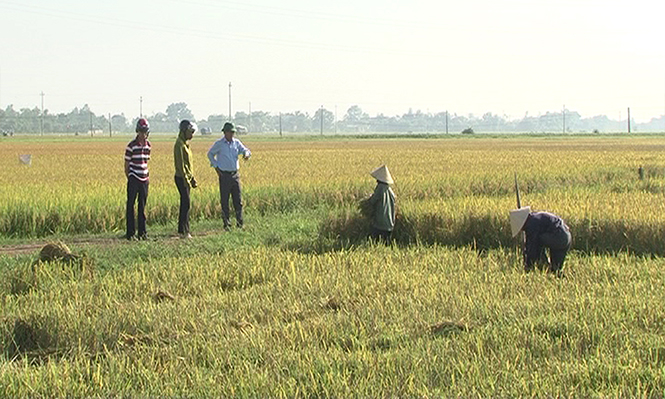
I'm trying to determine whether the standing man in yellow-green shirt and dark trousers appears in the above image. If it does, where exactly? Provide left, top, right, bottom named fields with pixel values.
left=173, top=119, right=197, bottom=238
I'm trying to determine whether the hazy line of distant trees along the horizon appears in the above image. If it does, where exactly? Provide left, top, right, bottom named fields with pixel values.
left=0, top=102, right=665, bottom=135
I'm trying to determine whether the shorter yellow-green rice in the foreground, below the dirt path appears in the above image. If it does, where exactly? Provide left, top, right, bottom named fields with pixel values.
left=0, top=230, right=665, bottom=397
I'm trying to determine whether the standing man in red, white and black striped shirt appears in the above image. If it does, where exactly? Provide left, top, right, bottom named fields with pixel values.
left=125, top=118, right=151, bottom=240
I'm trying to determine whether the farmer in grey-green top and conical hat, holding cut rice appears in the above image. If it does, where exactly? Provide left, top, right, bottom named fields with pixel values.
left=367, top=165, right=395, bottom=243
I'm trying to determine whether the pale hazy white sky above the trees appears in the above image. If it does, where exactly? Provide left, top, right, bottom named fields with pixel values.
left=0, top=0, right=665, bottom=122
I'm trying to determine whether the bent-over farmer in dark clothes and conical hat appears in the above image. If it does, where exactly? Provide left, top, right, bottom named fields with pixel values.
left=510, top=206, right=572, bottom=273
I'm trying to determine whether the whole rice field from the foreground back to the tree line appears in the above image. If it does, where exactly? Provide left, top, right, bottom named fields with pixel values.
left=0, top=136, right=665, bottom=397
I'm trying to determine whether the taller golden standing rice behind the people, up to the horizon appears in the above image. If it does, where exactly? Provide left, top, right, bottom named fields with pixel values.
left=0, top=136, right=665, bottom=254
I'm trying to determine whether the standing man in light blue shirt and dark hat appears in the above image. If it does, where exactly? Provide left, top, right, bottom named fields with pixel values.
left=208, top=122, right=252, bottom=231
